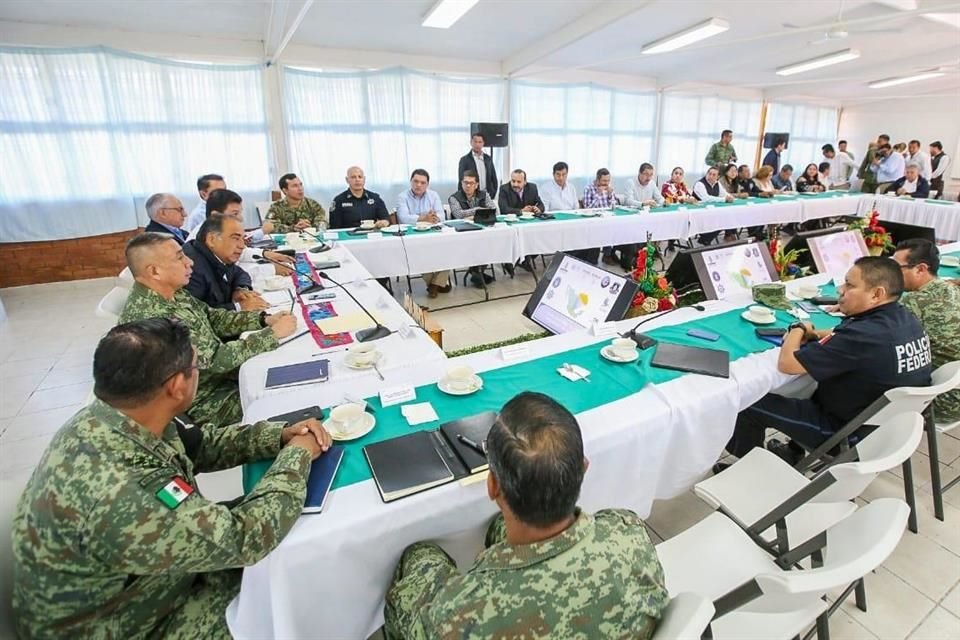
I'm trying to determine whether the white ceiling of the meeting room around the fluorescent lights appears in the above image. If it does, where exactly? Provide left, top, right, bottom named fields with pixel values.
left=0, top=0, right=960, bottom=102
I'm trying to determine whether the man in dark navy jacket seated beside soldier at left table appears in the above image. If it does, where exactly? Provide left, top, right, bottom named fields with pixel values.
left=183, top=213, right=269, bottom=311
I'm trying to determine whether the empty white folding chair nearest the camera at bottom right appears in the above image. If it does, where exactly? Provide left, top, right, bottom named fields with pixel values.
left=657, top=498, right=910, bottom=640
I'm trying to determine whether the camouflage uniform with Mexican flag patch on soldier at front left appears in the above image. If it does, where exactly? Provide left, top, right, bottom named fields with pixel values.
left=13, top=400, right=310, bottom=640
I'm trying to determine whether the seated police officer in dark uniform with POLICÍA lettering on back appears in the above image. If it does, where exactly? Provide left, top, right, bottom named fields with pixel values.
left=728, top=257, right=932, bottom=464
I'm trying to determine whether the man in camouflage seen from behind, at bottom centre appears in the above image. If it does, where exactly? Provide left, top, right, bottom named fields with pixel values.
left=384, top=392, right=669, bottom=640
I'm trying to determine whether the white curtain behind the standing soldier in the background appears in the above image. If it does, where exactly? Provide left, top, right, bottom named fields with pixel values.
left=657, top=93, right=762, bottom=183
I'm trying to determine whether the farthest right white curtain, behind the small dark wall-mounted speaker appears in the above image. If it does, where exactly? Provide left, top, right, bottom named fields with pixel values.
left=766, top=102, right=837, bottom=176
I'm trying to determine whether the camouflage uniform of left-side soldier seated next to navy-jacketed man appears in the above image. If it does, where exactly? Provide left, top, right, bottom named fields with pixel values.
left=120, top=282, right=278, bottom=424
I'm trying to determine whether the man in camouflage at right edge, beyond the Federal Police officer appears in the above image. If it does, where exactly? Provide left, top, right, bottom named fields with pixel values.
left=893, top=238, right=960, bottom=422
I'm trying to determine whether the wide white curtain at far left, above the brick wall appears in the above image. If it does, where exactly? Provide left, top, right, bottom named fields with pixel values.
left=0, top=47, right=270, bottom=242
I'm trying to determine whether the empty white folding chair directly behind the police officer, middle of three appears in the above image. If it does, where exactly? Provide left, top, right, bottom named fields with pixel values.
left=693, top=412, right=923, bottom=553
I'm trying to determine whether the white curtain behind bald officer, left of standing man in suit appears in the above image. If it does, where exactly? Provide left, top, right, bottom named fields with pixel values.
left=281, top=67, right=506, bottom=210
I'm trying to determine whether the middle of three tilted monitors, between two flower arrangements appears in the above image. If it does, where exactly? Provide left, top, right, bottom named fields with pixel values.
left=666, top=239, right=778, bottom=300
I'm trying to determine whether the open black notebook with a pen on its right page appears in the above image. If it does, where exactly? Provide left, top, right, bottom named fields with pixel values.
left=363, top=411, right=497, bottom=502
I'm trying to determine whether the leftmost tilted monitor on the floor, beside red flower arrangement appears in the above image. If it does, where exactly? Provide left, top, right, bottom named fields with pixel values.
left=523, top=253, right=637, bottom=334
